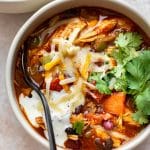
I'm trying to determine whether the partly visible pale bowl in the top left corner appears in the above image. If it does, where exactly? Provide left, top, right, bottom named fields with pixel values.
left=0, top=0, right=52, bottom=13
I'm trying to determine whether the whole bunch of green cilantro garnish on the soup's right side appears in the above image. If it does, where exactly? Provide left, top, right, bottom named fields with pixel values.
left=89, top=32, right=150, bottom=124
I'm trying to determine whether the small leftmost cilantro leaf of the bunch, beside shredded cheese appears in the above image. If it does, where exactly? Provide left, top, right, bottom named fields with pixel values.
left=88, top=72, right=111, bottom=94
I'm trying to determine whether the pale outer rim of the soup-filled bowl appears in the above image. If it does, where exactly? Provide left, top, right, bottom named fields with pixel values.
left=5, top=0, right=150, bottom=150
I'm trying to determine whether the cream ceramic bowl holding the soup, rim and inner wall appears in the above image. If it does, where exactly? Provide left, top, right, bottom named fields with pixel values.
left=6, top=0, right=150, bottom=150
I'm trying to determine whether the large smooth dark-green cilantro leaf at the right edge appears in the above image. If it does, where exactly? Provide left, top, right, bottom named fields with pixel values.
left=125, top=51, right=150, bottom=91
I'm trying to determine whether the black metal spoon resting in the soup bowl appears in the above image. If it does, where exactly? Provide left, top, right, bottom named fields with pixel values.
left=21, top=44, right=56, bottom=150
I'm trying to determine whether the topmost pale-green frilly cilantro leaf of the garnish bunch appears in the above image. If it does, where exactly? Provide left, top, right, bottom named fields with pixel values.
left=112, top=32, right=142, bottom=65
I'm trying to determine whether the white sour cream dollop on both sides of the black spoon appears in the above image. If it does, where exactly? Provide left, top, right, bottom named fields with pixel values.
left=19, top=79, right=85, bottom=146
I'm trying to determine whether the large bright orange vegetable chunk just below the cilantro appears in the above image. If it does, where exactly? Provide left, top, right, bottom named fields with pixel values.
left=103, top=92, right=126, bottom=115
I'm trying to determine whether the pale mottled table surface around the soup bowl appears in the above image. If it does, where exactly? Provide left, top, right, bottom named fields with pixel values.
left=0, top=0, right=150, bottom=150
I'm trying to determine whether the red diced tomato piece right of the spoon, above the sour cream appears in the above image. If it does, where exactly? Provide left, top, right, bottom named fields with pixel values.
left=50, top=78, right=63, bottom=92
